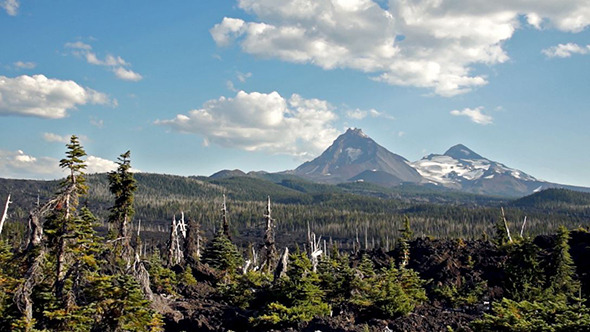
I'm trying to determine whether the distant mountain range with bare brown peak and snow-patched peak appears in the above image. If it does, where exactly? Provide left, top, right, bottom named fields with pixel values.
left=286, top=129, right=590, bottom=197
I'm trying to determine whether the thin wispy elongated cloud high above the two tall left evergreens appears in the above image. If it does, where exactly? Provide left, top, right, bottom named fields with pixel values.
left=65, top=41, right=143, bottom=82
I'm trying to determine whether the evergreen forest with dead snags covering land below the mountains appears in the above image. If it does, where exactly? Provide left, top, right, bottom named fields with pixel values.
left=0, top=136, right=590, bottom=331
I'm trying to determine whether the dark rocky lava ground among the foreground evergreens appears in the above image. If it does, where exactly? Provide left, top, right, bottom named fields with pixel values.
left=154, top=232, right=590, bottom=332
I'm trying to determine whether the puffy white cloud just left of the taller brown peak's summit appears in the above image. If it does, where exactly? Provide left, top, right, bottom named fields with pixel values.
left=155, top=91, right=338, bottom=159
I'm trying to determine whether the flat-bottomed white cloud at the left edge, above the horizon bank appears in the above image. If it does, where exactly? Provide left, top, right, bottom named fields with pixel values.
left=0, top=75, right=113, bottom=119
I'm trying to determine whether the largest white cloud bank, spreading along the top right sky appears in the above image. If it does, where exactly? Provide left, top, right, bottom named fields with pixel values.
left=210, top=0, right=590, bottom=96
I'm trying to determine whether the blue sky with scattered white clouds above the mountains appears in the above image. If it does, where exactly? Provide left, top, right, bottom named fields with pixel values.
left=0, top=0, right=590, bottom=187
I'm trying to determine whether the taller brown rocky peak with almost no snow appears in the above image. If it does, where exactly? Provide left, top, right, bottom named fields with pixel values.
left=293, top=129, right=422, bottom=184
